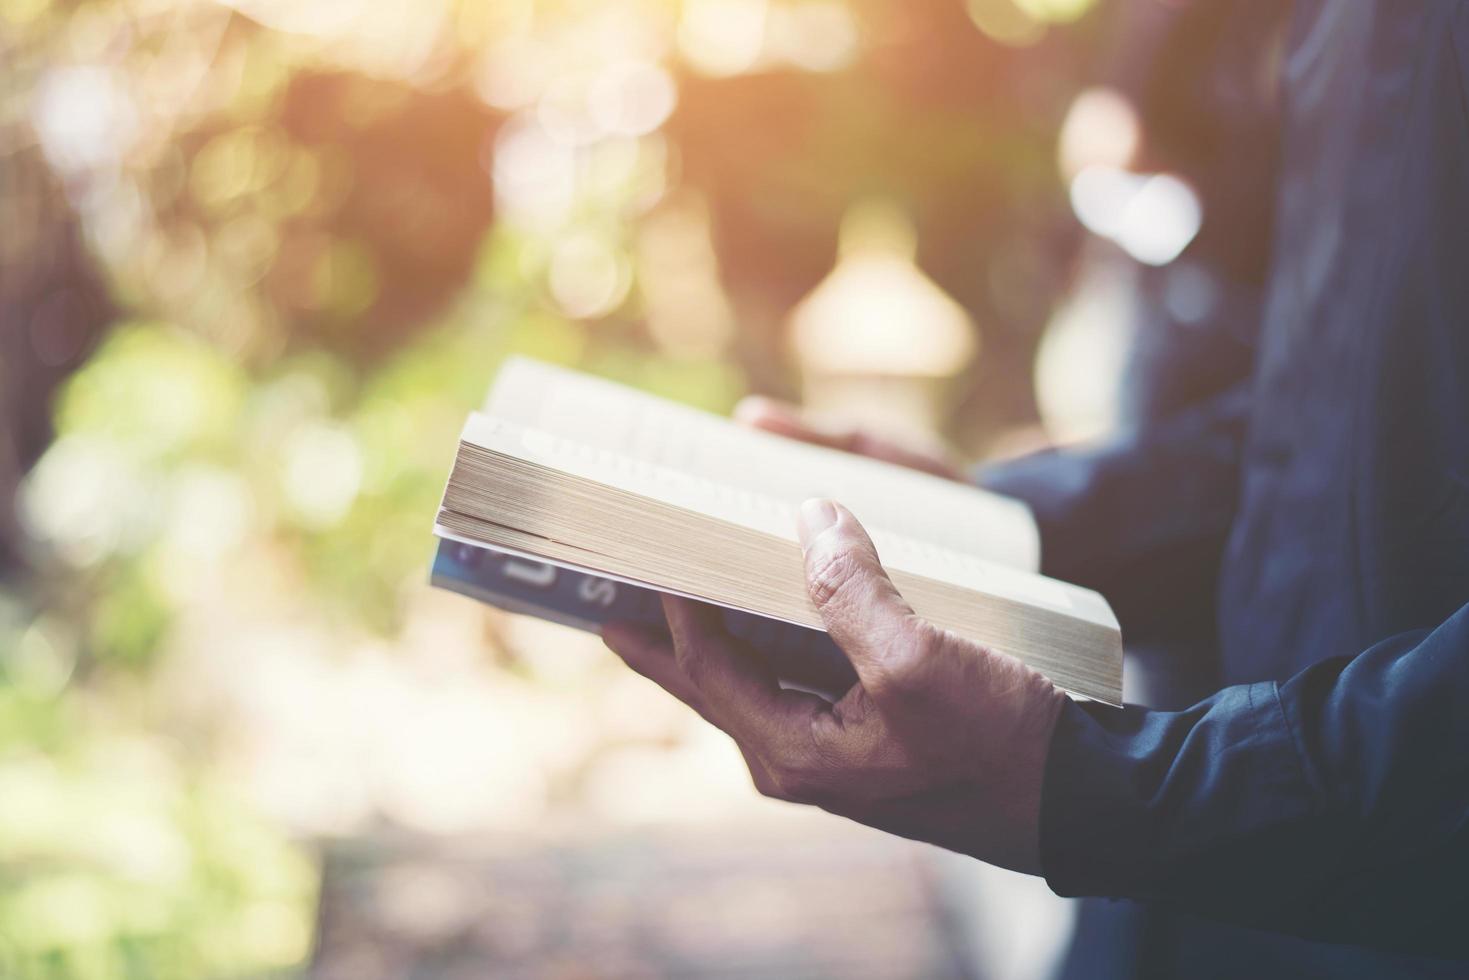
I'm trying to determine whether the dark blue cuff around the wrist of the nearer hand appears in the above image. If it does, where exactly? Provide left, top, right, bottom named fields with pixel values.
left=1040, top=683, right=1306, bottom=899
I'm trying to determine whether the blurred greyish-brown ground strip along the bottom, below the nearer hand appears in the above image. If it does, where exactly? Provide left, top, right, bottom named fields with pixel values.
left=311, top=820, right=993, bottom=980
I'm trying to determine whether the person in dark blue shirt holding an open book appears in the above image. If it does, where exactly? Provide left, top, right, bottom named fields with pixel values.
left=605, top=0, right=1469, bottom=958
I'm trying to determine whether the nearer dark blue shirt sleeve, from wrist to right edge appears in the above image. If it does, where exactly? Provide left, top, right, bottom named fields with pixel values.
left=1042, top=605, right=1469, bottom=958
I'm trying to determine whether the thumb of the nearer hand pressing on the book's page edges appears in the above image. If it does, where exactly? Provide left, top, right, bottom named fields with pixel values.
left=799, top=500, right=921, bottom=695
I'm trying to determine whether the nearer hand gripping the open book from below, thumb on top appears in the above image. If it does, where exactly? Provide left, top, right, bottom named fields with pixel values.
left=602, top=500, right=1064, bottom=873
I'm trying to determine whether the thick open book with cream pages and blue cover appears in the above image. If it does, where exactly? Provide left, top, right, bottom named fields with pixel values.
left=433, top=359, right=1122, bottom=704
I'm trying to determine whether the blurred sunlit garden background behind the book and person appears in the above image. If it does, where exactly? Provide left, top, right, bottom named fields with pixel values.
left=0, top=0, right=1251, bottom=979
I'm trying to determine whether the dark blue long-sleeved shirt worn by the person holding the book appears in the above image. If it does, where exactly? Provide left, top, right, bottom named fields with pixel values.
left=984, top=0, right=1469, bottom=956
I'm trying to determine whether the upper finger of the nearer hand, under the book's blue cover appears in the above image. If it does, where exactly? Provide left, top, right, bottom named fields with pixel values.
left=663, top=595, right=829, bottom=746
